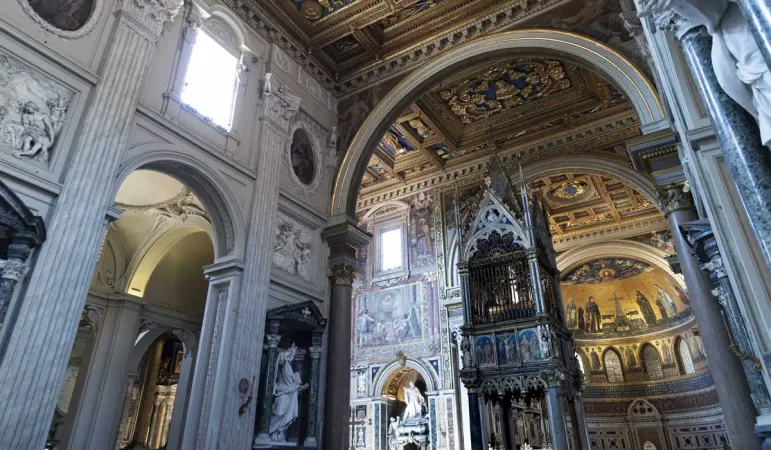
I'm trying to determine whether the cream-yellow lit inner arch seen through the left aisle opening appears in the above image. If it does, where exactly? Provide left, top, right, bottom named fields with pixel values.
left=124, top=216, right=214, bottom=297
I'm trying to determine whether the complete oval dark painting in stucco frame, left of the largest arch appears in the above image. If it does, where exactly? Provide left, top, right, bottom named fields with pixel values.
left=284, top=113, right=324, bottom=197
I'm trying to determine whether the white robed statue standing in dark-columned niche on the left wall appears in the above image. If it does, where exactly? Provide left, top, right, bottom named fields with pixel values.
left=268, top=344, right=308, bottom=442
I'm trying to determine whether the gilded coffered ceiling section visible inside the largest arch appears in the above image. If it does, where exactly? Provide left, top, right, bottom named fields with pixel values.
left=362, top=57, right=639, bottom=192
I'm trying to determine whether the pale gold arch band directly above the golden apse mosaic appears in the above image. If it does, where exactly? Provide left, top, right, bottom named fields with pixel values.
left=557, top=240, right=686, bottom=291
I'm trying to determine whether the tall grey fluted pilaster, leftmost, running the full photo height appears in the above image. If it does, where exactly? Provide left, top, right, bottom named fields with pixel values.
left=0, top=0, right=182, bottom=450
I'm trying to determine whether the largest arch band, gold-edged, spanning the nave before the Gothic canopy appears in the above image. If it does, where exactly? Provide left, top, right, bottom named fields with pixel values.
left=330, top=29, right=667, bottom=216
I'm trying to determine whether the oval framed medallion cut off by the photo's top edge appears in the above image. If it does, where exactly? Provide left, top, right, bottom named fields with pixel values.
left=19, top=0, right=106, bottom=39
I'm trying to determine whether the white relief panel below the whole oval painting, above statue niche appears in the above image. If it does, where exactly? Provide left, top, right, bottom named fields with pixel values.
left=273, top=213, right=313, bottom=281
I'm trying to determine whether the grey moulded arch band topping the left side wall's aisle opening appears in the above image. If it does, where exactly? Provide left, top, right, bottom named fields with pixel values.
left=112, top=148, right=246, bottom=259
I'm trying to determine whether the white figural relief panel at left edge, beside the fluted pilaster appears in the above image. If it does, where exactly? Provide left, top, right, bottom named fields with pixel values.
left=0, top=52, right=75, bottom=165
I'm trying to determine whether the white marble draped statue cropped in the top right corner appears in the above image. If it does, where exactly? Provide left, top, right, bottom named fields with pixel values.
left=639, top=0, right=771, bottom=145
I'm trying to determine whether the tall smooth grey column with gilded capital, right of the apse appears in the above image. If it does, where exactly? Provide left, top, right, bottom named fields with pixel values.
left=661, top=186, right=760, bottom=449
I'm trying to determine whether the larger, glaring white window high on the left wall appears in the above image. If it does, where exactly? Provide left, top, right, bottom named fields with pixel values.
left=182, top=32, right=238, bottom=130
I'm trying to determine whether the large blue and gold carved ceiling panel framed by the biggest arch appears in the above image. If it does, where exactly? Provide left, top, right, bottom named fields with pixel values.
left=439, top=58, right=572, bottom=124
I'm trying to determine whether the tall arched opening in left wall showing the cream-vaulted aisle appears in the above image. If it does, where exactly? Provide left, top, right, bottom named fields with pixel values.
left=49, top=164, right=232, bottom=449
